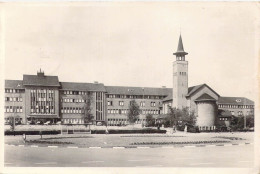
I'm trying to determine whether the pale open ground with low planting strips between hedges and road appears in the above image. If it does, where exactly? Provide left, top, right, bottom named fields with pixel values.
left=5, top=132, right=254, bottom=147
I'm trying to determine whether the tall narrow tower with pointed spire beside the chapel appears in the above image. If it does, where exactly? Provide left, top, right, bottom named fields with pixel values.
left=172, top=35, right=188, bottom=109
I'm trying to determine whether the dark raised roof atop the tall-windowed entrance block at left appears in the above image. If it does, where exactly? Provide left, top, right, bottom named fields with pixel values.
left=23, top=75, right=60, bottom=87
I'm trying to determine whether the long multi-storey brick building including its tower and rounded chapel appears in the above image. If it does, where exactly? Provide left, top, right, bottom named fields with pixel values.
left=5, top=36, right=254, bottom=127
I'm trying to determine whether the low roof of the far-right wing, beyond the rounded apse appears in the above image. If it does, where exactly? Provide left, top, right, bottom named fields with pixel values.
left=218, top=97, right=254, bottom=105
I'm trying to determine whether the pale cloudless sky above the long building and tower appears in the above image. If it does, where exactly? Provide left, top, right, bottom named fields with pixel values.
left=2, top=2, right=259, bottom=99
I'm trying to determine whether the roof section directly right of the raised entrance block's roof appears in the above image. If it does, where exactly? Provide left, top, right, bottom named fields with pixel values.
left=60, top=82, right=106, bottom=92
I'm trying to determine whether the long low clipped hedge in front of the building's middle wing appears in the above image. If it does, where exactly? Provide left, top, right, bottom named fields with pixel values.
left=91, top=129, right=166, bottom=134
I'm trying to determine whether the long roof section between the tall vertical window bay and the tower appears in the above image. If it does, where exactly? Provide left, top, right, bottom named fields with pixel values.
left=105, top=86, right=172, bottom=96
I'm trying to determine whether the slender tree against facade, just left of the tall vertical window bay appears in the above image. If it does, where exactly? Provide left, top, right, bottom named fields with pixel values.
left=81, top=92, right=94, bottom=123
